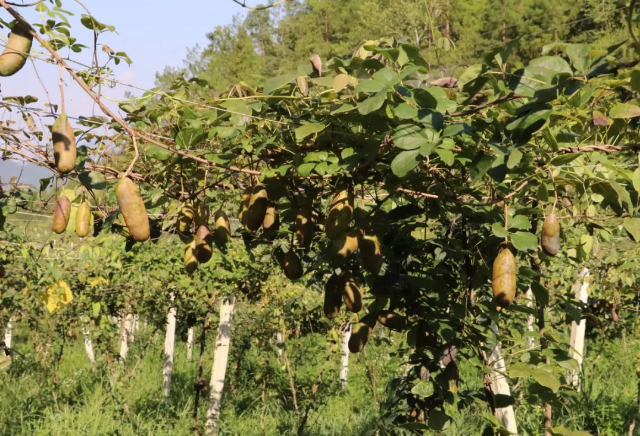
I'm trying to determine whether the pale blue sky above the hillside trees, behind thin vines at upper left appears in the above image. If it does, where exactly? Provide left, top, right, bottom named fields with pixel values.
left=0, top=0, right=251, bottom=186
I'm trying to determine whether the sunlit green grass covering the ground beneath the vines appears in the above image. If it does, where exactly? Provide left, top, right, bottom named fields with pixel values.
left=0, top=326, right=640, bottom=436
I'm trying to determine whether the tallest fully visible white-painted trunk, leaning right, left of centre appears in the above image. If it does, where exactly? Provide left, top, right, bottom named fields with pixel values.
left=205, top=295, right=236, bottom=435
